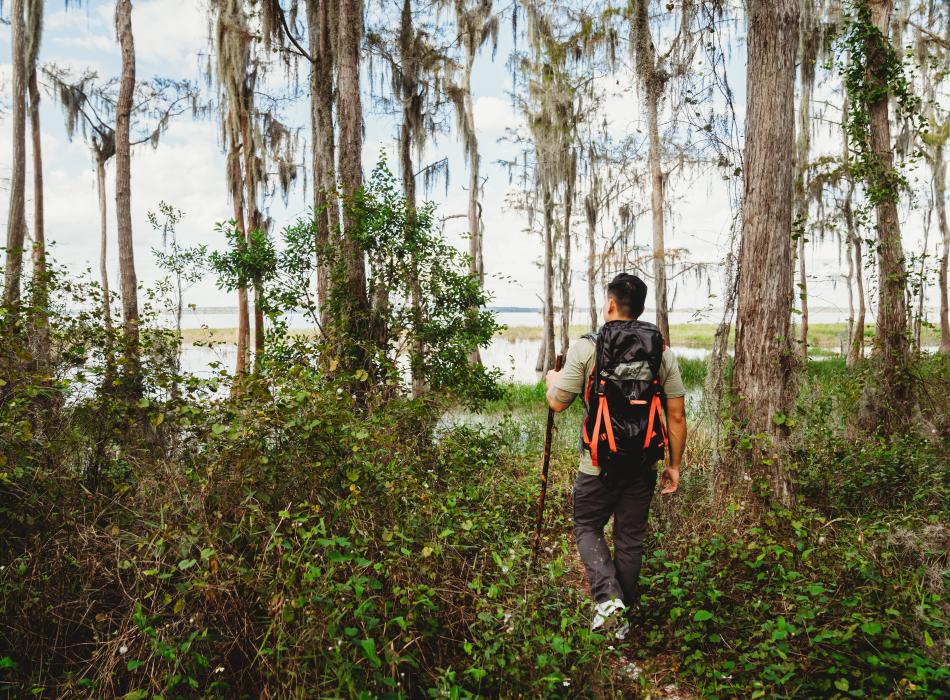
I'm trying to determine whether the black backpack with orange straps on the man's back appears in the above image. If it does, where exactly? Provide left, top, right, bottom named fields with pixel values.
left=582, top=321, right=667, bottom=476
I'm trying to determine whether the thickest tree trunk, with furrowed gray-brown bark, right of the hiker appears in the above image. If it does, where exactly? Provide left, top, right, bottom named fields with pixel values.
left=724, top=0, right=798, bottom=503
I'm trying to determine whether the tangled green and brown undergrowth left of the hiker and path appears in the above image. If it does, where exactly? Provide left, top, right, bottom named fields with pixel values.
left=0, top=375, right=624, bottom=698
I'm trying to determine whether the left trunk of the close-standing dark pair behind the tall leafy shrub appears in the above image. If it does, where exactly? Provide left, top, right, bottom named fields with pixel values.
left=307, top=0, right=339, bottom=319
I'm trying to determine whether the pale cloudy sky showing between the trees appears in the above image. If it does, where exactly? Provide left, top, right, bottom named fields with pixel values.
left=0, top=0, right=937, bottom=330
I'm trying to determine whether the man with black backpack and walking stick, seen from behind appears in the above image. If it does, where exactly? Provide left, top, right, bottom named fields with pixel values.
left=546, top=273, right=686, bottom=639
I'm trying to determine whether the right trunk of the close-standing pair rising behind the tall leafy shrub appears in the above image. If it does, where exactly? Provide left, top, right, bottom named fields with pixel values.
left=336, top=0, right=370, bottom=346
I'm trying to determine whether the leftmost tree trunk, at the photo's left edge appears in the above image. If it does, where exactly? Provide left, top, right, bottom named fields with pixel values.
left=3, top=0, right=26, bottom=314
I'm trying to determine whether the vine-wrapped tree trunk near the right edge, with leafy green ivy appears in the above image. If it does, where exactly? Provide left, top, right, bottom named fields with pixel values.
left=860, top=0, right=915, bottom=433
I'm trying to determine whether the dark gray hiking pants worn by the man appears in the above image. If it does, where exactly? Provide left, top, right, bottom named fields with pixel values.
left=574, top=469, right=656, bottom=606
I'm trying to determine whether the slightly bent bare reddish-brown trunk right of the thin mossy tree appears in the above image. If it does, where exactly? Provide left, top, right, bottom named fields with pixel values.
left=115, top=0, right=139, bottom=360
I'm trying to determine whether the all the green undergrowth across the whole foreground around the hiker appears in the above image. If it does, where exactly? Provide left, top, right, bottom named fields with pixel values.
left=0, top=344, right=950, bottom=700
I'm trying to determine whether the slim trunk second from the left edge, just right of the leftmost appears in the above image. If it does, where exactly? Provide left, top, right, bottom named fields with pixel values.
left=29, top=65, right=49, bottom=361
